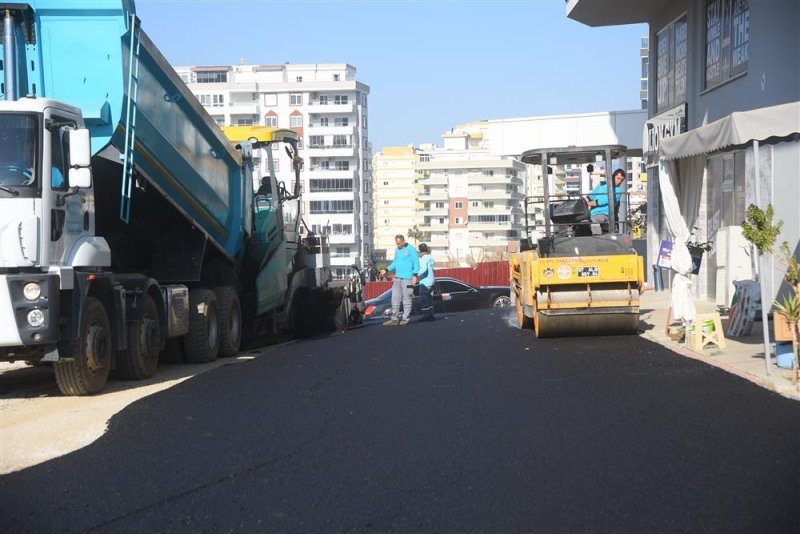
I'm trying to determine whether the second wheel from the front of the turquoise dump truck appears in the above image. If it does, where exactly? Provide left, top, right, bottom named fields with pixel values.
left=114, top=295, right=161, bottom=380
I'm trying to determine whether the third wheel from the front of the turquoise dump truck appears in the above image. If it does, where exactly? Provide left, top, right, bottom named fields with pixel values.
left=183, top=289, right=219, bottom=363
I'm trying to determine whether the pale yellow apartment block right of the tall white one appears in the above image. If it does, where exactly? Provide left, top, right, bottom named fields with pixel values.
left=372, top=146, right=430, bottom=261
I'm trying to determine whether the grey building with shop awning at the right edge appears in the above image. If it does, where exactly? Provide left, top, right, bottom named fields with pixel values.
left=566, top=0, right=800, bottom=306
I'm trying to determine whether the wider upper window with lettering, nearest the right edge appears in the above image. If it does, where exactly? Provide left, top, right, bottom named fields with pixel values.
left=704, top=0, right=750, bottom=89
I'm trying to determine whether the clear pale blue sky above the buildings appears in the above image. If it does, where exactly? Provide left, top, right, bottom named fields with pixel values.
left=136, top=0, right=647, bottom=152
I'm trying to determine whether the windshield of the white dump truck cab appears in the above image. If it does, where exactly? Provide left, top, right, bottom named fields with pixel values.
left=0, top=113, right=39, bottom=196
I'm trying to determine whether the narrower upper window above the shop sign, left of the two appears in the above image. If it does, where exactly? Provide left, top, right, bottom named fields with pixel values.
left=656, top=17, right=689, bottom=112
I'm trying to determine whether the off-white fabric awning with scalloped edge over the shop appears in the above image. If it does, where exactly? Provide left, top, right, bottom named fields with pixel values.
left=658, top=102, right=800, bottom=160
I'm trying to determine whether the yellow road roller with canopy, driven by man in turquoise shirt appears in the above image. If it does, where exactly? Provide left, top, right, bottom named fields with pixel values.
left=509, top=145, right=644, bottom=337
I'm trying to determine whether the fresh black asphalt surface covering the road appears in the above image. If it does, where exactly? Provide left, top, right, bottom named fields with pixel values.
left=0, top=309, right=800, bottom=533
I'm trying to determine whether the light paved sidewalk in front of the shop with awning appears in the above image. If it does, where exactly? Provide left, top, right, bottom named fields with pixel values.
left=640, top=291, right=800, bottom=400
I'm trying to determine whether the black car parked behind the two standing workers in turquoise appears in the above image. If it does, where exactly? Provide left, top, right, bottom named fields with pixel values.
left=364, top=277, right=511, bottom=319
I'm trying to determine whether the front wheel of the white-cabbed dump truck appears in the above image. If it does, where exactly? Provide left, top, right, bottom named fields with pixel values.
left=53, top=297, right=112, bottom=395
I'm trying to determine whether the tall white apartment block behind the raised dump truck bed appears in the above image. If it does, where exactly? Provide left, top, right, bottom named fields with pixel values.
left=175, top=61, right=372, bottom=278
